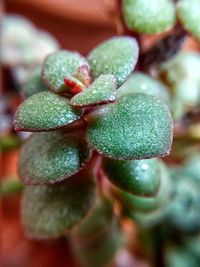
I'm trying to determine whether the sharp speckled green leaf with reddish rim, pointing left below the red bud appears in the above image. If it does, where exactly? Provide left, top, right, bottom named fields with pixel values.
left=14, top=92, right=82, bottom=132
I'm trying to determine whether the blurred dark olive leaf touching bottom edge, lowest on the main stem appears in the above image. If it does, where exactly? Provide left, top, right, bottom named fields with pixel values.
left=71, top=207, right=123, bottom=267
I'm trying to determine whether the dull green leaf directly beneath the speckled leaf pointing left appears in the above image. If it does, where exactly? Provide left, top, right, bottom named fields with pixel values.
left=19, top=130, right=90, bottom=184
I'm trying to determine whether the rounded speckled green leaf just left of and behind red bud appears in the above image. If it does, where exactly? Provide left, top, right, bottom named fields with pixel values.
left=42, top=50, right=88, bottom=93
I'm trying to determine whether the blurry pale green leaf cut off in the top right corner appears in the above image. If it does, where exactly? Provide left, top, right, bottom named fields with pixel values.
left=177, top=0, right=200, bottom=40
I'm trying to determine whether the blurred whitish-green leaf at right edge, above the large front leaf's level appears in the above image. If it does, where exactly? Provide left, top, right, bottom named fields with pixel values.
left=160, top=52, right=200, bottom=108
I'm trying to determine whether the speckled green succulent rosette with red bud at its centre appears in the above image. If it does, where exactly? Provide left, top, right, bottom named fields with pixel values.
left=14, top=36, right=173, bottom=241
